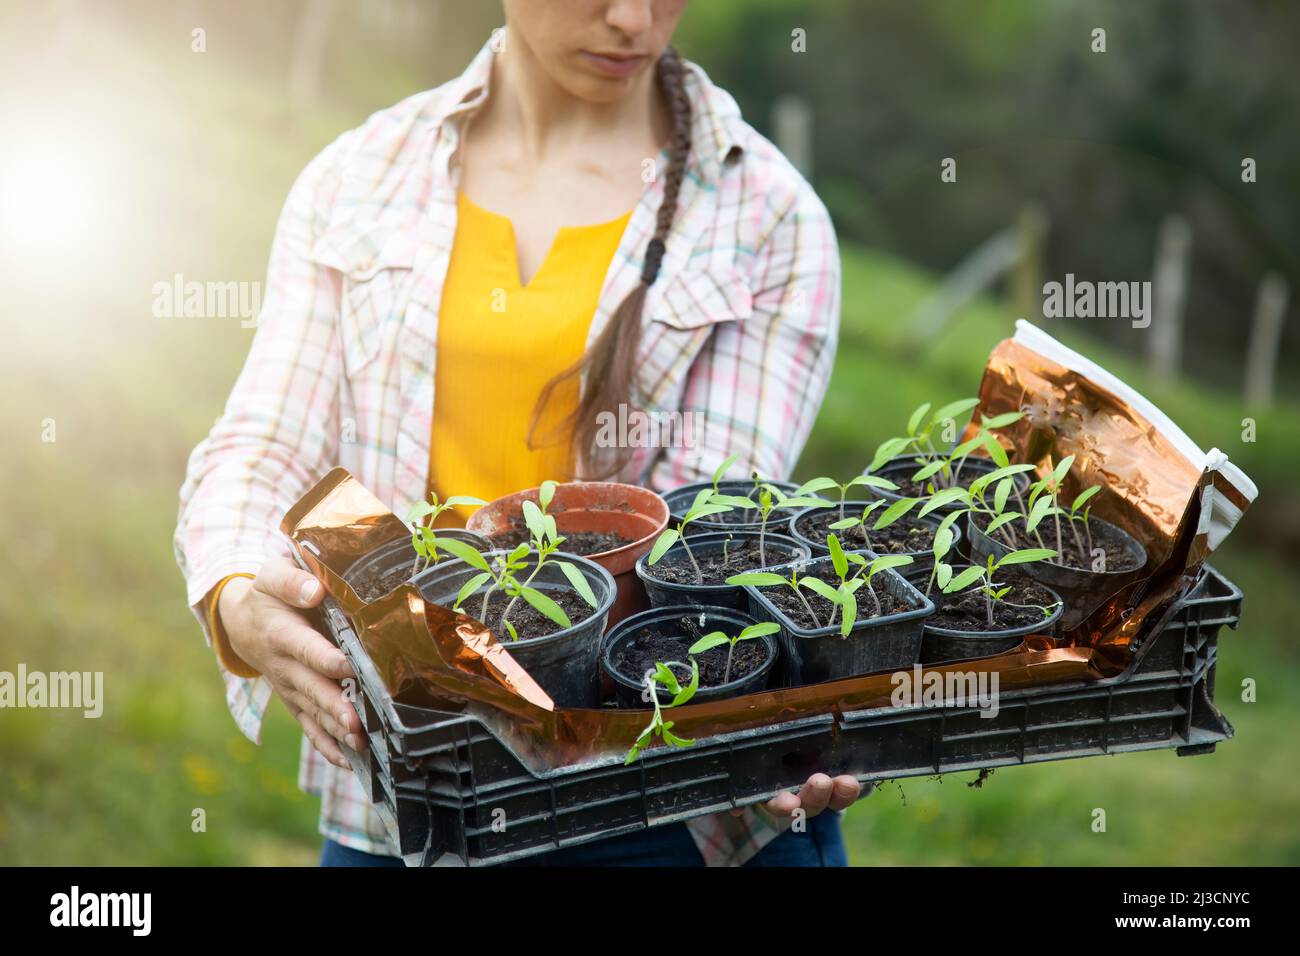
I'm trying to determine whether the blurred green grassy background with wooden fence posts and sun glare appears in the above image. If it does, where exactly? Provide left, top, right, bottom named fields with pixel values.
left=0, top=0, right=1300, bottom=865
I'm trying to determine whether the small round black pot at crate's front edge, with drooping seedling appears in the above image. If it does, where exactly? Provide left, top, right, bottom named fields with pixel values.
left=601, top=605, right=779, bottom=710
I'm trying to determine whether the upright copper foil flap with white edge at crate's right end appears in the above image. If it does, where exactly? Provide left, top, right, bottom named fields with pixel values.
left=967, top=320, right=1257, bottom=672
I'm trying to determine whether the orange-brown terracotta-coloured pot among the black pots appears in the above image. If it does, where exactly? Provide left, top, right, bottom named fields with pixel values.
left=465, top=481, right=668, bottom=627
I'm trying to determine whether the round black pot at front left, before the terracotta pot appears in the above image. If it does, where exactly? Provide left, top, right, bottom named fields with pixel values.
left=415, top=551, right=616, bottom=708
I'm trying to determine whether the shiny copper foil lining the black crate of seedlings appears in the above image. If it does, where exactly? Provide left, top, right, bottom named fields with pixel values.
left=281, top=323, right=1255, bottom=775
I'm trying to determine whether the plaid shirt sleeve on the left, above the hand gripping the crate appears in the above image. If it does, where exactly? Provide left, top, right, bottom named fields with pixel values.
left=173, top=137, right=347, bottom=741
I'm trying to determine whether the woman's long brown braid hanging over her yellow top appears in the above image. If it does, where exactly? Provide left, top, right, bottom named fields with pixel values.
left=528, top=47, right=690, bottom=477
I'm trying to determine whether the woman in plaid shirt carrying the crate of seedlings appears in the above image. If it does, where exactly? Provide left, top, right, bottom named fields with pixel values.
left=177, top=0, right=859, bottom=865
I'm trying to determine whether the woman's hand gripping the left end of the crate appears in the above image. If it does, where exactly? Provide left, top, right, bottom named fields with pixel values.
left=217, top=558, right=365, bottom=769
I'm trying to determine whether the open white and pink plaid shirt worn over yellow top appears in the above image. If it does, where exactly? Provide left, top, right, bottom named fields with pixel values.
left=176, top=33, right=840, bottom=865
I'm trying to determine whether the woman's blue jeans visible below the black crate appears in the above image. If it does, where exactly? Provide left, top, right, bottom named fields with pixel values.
left=321, top=810, right=849, bottom=866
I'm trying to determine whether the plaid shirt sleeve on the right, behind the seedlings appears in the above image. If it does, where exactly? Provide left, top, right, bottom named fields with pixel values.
left=651, top=185, right=840, bottom=489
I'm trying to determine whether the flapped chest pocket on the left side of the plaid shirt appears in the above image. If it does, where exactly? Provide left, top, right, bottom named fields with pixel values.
left=311, top=232, right=416, bottom=378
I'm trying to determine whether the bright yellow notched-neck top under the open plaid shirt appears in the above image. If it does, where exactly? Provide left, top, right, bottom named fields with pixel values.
left=429, top=194, right=632, bottom=524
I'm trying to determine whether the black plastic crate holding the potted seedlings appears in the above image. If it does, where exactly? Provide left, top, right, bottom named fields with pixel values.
left=324, top=567, right=1242, bottom=866
